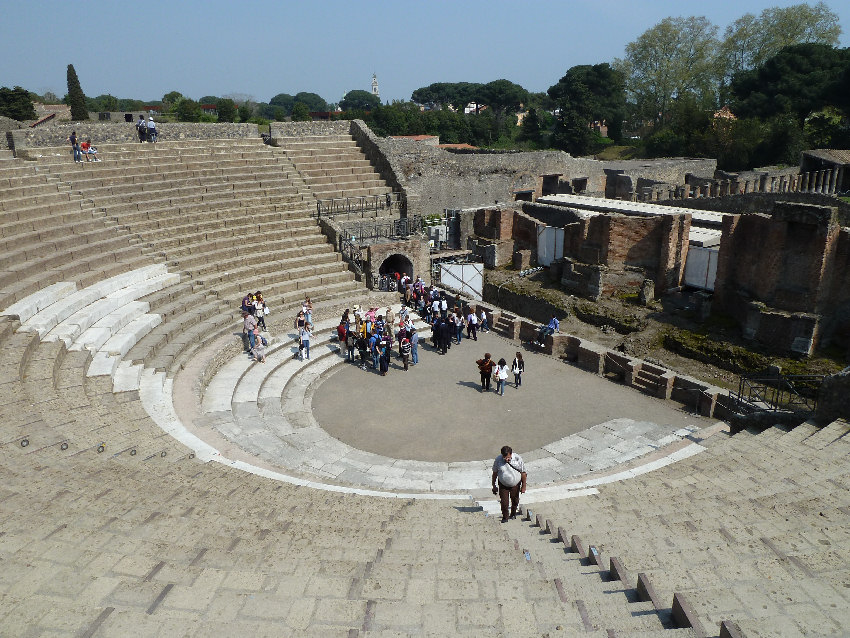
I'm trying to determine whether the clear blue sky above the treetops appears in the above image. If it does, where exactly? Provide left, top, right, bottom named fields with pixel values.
left=0, top=0, right=850, bottom=102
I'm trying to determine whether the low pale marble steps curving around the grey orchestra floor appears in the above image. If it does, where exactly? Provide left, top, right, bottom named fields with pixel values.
left=189, top=306, right=702, bottom=507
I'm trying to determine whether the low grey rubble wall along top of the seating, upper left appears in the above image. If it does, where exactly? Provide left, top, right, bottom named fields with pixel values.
left=12, top=122, right=260, bottom=152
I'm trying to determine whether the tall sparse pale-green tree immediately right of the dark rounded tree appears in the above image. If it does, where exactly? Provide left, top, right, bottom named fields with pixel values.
left=615, top=16, right=720, bottom=125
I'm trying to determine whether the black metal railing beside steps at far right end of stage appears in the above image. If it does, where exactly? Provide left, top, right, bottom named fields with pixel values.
left=729, top=374, right=825, bottom=412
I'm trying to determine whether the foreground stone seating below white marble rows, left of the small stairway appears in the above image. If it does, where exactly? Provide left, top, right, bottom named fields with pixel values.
left=0, top=317, right=608, bottom=638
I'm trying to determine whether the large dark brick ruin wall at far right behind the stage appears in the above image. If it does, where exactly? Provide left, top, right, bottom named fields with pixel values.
left=714, top=203, right=850, bottom=354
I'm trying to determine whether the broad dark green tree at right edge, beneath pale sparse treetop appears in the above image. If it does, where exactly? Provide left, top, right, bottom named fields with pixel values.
left=730, top=44, right=850, bottom=126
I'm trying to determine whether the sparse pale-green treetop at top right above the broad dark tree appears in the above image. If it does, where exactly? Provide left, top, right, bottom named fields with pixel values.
left=721, top=2, right=841, bottom=80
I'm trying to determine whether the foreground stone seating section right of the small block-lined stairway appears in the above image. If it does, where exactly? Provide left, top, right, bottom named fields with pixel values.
left=533, top=420, right=850, bottom=637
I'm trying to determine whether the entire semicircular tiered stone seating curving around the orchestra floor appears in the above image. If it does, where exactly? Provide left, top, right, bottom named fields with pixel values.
left=0, top=134, right=850, bottom=638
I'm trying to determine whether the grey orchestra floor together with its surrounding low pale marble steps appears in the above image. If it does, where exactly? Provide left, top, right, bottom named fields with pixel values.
left=189, top=308, right=714, bottom=495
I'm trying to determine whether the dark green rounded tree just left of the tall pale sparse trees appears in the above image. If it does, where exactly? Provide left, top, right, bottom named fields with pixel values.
left=548, top=62, right=626, bottom=140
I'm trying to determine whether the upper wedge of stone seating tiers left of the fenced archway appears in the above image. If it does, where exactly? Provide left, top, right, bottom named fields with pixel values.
left=9, top=140, right=358, bottom=374
